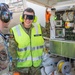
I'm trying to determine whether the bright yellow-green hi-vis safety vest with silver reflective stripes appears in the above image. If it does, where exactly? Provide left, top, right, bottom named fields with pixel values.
left=12, top=24, right=44, bottom=67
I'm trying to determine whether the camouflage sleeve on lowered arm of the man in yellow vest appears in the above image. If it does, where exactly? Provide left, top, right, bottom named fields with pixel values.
left=9, top=34, right=17, bottom=71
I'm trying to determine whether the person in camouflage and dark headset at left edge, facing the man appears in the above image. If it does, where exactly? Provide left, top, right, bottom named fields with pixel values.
left=0, top=3, right=12, bottom=75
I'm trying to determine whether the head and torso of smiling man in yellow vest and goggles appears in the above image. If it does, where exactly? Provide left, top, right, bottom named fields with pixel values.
left=11, top=8, right=44, bottom=75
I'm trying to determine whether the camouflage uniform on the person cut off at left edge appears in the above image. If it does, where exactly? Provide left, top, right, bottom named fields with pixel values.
left=0, top=34, right=9, bottom=75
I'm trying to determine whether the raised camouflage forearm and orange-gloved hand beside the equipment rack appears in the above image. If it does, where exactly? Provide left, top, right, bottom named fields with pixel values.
left=45, top=8, right=51, bottom=37
